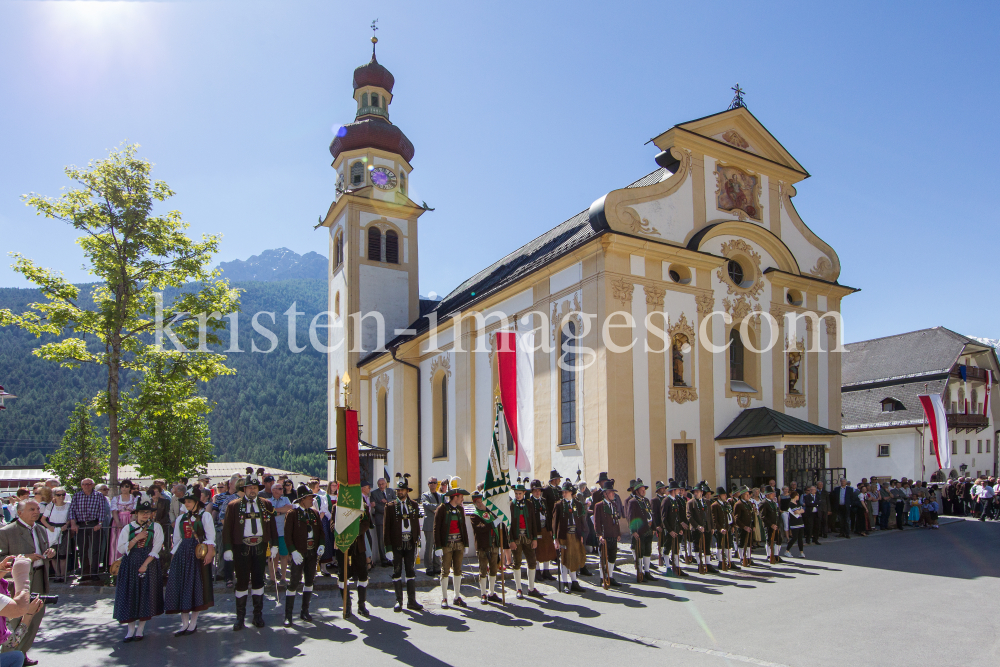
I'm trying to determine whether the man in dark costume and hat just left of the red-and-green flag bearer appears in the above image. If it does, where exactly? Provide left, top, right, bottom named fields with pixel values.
left=285, top=484, right=326, bottom=627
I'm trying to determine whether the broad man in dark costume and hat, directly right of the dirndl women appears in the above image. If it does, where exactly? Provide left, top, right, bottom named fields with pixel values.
left=222, top=469, right=278, bottom=631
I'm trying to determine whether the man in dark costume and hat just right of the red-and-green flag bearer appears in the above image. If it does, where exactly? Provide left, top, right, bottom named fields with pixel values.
left=382, top=472, right=423, bottom=612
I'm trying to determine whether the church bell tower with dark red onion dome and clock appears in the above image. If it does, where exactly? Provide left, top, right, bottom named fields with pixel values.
left=317, top=37, right=428, bottom=440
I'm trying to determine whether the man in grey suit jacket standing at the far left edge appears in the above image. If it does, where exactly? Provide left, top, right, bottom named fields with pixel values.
left=0, top=500, right=55, bottom=665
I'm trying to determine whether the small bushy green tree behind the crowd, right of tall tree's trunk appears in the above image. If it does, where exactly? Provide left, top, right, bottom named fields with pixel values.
left=123, top=359, right=212, bottom=480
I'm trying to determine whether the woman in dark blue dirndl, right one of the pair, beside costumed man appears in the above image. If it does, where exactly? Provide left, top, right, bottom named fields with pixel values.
left=166, top=485, right=215, bottom=637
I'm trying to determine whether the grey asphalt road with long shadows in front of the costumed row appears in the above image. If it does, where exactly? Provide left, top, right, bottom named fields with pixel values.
left=32, top=521, right=1000, bottom=667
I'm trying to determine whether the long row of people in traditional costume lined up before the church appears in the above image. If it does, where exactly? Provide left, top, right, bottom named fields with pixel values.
left=112, top=470, right=832, bottom=642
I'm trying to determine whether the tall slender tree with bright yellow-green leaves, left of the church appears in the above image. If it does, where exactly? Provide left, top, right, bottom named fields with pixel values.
left=0, top=144, right=239, bottom=484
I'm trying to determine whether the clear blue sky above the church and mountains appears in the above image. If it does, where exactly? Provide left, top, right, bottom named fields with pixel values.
left=0, top=0, right=1000, bottom=341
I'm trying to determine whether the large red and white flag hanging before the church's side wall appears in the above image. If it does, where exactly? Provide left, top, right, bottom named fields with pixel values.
left=495, top=331, right=535, bottom=472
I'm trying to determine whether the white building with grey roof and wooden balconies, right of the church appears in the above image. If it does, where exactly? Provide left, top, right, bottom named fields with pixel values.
left=841, top=327, right=1000, bottom=483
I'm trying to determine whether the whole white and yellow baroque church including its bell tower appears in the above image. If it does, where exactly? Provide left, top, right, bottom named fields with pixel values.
left=321, top=49, right=855, bottom=489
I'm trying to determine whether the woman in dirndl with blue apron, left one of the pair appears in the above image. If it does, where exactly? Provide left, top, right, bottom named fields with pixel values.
left=114, top=497, right=163, bottom=643
